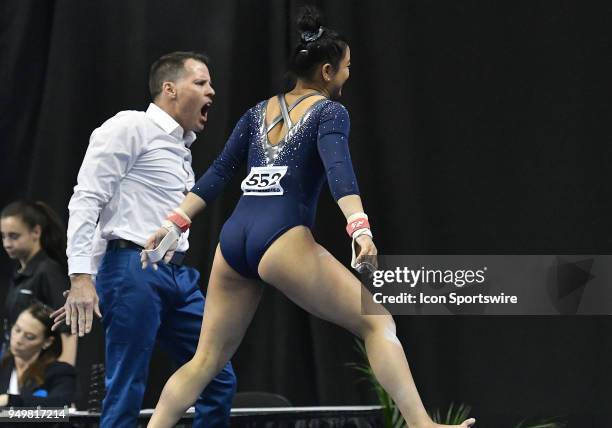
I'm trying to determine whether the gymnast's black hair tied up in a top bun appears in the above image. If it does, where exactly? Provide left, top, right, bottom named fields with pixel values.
left=289, top=6, right=348, bottom=80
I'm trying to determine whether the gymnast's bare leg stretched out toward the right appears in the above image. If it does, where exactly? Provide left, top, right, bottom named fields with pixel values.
left=259, top=227, right=474, bottom=428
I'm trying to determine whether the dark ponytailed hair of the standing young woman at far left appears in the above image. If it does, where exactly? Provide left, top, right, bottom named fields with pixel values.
left=0, top=201, right=67, bottom=271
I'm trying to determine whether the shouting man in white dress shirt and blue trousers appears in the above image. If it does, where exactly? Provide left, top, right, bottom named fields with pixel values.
left=54, top=52, right=236, bottom=428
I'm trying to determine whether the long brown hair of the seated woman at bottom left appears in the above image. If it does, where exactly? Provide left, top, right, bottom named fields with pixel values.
left=0, top=302, right=62, bottom=387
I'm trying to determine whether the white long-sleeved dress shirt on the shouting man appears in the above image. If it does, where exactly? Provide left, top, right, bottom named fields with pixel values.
left=66, top=104, right=196, bottom=274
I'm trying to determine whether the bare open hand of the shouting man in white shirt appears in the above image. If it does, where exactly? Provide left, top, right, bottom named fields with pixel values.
left=51, top=273, right=102, bottom=337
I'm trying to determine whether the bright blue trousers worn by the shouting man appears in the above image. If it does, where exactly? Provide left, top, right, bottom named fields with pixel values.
left=96, top=248, right=236, bottom=428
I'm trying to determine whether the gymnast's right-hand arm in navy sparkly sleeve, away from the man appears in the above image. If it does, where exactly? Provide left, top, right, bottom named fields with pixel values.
left=317, top=102, right=377, bottom=263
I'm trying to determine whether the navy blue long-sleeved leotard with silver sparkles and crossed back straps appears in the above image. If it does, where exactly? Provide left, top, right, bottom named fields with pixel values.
left=191, top=96, right=359, bottom=278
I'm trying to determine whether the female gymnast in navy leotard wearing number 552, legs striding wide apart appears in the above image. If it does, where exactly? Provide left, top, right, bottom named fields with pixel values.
left=142, top=8, right=475, bottom=428
